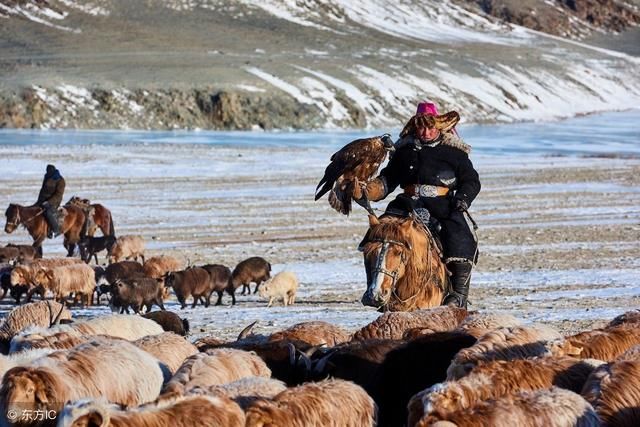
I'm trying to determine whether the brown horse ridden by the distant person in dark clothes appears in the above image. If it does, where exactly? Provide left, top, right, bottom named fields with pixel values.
left=4, top=203, right=85, bottom=256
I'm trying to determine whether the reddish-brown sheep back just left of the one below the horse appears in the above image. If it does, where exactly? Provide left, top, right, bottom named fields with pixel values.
left=269, top=320, right=351, bottom=347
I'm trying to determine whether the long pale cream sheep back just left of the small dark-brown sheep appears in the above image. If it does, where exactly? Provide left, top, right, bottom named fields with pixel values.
left=11, top=314, right=164, bottom=353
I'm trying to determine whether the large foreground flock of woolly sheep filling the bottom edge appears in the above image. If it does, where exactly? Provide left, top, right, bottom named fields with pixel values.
left=0, top=300, right=640, bottom=427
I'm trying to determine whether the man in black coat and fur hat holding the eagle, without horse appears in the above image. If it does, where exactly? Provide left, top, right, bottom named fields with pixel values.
left=363, top=102, right=480, bottom=308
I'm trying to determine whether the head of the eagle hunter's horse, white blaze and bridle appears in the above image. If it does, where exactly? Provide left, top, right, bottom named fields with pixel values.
left=362, top=215, right=412, bottom=308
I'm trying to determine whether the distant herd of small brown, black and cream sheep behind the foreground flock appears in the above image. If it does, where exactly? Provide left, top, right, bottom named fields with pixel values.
left=0, top=236, right=298, bottom=313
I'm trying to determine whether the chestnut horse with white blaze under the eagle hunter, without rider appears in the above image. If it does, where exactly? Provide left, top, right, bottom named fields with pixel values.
left=361, top=215, right=448, bottom=311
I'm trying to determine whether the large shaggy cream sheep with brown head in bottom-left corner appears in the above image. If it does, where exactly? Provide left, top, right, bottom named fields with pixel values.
left=0, top=340, right=163, bottom=422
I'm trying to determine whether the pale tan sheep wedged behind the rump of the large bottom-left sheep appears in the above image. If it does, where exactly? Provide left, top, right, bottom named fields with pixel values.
left=133, top=332, right=198, bottom=375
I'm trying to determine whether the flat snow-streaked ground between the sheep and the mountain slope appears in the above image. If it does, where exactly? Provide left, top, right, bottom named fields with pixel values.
left=0, top=111, right=640, bottom=338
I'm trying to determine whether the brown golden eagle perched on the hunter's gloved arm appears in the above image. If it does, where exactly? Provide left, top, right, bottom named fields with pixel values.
left=315, top=134, right=395, bottom=215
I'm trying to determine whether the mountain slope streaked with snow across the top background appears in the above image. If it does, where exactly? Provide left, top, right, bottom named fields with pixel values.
left=0, top=0, right=640, bottom=129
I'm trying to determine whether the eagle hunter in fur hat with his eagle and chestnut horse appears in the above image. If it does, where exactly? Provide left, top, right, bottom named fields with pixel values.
left=316, top=102, right=480, bottom=311
